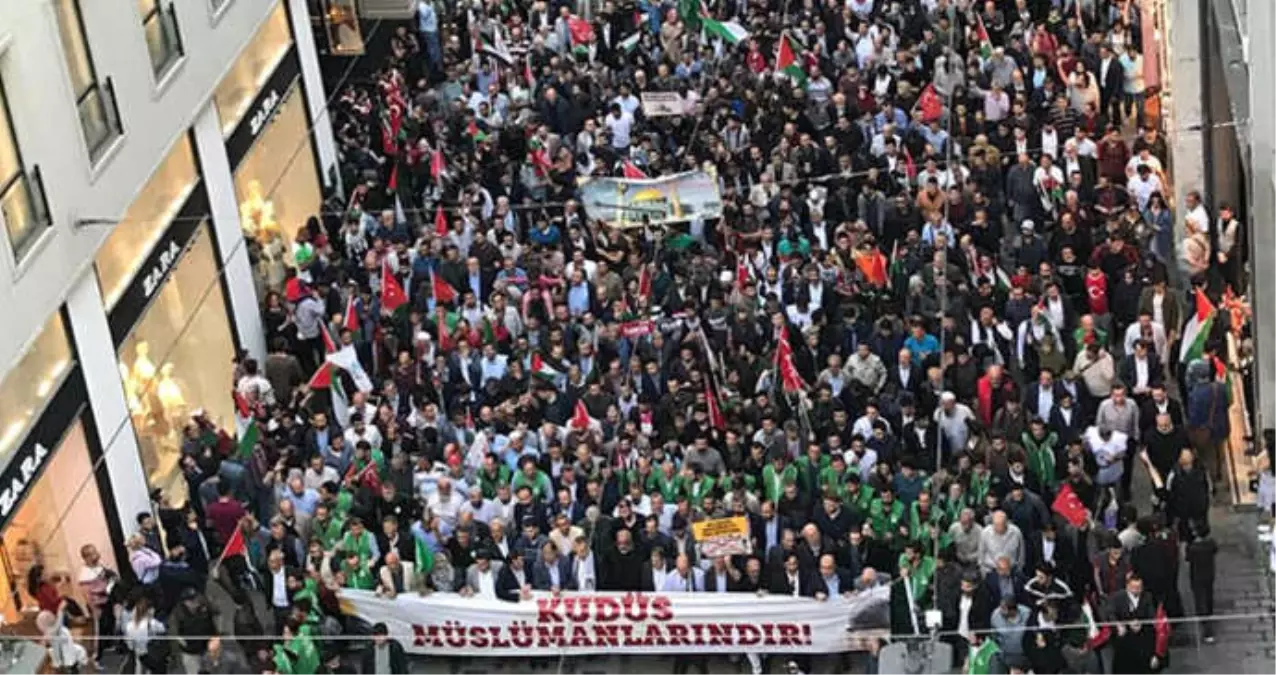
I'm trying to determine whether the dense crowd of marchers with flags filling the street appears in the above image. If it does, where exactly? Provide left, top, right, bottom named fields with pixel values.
left=19, top=0, right=1244, bottom=675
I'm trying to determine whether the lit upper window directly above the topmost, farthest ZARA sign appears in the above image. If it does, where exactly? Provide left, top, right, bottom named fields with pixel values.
left=213, top=3, right=292, bottom=137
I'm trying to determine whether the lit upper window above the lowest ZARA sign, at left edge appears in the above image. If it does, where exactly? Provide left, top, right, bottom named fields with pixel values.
left=0, top=311, right=71, bottom=466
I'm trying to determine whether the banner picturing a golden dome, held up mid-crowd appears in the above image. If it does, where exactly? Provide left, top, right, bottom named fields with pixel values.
left=581, top=171, right=722, bottom=227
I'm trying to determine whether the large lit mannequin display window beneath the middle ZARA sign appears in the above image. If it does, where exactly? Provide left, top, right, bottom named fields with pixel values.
left=119, top=223, right=235, bottom=504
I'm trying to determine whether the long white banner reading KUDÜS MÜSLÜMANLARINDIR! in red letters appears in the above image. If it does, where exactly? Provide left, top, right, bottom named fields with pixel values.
left=341, top=586, right=889, bottom=657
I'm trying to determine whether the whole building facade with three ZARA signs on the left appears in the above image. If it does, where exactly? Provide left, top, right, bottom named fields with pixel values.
left=0, top=0, right=337, bottom=621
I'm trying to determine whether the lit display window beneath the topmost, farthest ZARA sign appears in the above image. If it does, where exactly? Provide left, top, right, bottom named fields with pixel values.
left=235, top=84, right=323, bottom=290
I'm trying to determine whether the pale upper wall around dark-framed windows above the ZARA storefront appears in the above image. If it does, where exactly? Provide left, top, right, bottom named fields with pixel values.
left=0, top=0, right=284, bottom=372
